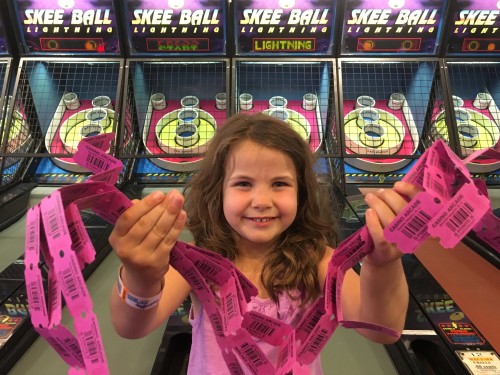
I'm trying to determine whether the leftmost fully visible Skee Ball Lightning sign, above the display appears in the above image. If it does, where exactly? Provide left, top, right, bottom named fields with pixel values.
left=14, top=0, right=120, bottom=55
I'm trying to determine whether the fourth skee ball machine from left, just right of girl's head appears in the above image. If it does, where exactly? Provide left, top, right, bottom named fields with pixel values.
left=339, top=0, right=447, bottom=184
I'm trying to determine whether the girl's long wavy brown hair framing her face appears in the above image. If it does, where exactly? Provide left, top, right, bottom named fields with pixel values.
left=184, top=114, right=336, bottom=305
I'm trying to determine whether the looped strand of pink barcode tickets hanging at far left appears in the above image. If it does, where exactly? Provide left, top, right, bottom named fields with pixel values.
left=25, top=135, right=131, bottom=374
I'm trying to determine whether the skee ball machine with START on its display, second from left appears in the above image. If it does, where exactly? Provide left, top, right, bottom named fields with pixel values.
left=118, top=0, right=230, bottom=186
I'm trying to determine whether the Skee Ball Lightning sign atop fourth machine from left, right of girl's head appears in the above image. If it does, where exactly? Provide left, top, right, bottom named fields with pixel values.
left=341, top=0, right=446, bottom=55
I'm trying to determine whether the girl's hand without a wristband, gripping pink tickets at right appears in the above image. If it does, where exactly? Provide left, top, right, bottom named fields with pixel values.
left=363, top=181, right=420, bottom=267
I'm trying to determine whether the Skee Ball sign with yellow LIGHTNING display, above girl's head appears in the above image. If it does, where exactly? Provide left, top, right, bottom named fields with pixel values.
left=234, top=0, right=336, bottom=54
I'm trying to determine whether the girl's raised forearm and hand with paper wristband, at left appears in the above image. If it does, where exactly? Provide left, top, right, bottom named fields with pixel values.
left=109, top=190, right=190, bottom=338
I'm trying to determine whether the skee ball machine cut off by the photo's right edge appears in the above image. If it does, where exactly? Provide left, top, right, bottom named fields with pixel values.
left=440, top=0, right=500, bottom=186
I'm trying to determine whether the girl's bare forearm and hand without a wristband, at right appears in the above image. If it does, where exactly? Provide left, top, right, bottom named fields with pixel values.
left=320, top=182, right=419, bottom=344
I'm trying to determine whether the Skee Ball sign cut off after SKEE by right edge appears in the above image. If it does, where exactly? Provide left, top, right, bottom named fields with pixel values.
left=447, top=0, right=500, bottom=55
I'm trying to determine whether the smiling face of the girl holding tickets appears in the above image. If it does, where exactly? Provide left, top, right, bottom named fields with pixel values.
left=223, top=140, right=298, bottom=250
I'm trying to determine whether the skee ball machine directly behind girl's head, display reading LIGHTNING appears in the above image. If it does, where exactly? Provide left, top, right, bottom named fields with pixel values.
left=232, top=0, right=343, bottom=232
